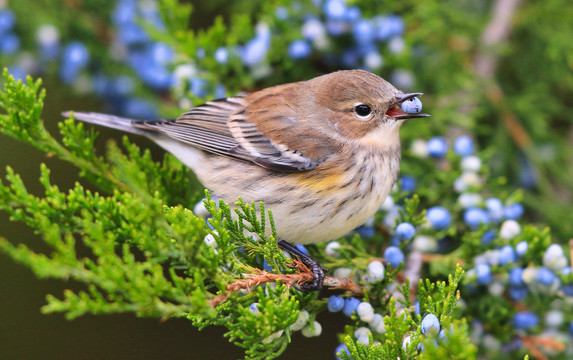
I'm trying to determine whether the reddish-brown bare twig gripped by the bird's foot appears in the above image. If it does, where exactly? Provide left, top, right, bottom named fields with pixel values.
left=209, top=260, right=364, bottom=307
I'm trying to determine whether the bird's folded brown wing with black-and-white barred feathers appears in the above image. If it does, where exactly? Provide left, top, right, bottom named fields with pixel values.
left=133, top=88, right=332, bottom=172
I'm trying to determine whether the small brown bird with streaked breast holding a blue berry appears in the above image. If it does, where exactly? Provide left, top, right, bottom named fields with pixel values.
left=63, top=70, right=429, bottom=291
